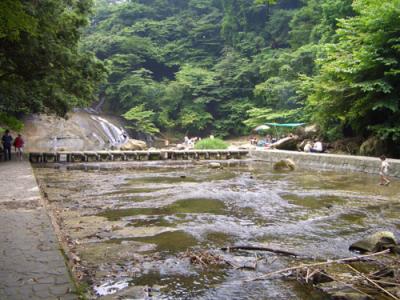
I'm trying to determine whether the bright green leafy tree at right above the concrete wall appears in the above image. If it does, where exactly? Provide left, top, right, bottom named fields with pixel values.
left=304, top=0, right=400, bottom=141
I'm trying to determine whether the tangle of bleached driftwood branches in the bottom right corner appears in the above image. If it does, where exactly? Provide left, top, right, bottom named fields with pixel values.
left=251, top=250, right=400, bottom=300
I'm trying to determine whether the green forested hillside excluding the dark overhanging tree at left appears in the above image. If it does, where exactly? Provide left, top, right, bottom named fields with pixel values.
left=79, top=0, right=400, bottom=155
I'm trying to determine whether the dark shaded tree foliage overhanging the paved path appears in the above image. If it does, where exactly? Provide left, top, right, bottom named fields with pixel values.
left=0, top=0, right=104, bottom=115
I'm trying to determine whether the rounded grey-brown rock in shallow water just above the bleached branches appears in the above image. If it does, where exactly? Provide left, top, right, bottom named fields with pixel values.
left=349, top=231, right=397, bottom=253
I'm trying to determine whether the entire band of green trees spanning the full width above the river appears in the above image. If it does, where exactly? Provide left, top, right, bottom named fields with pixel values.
left=0, top=0, right=400, bottom=155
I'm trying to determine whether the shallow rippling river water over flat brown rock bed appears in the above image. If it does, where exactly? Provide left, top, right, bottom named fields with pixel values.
left=35, top=161, right=400, bottom=299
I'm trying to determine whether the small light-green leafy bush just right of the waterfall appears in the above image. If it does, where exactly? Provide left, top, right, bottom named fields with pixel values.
left=122, top=105, right=159, bottom=134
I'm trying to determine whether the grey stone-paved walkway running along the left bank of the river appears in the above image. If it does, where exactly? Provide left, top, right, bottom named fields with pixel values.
left=0, top=161, right=77, bottom=300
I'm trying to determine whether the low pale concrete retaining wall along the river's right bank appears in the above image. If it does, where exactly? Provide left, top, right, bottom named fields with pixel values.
left=250, top=150, right=400, bottom=177
